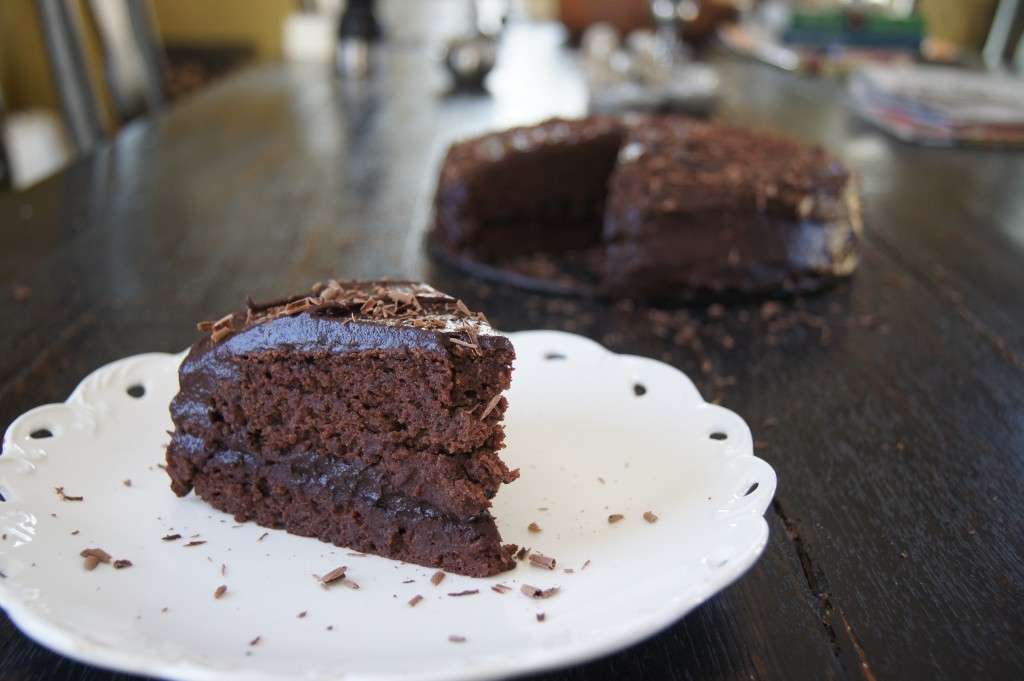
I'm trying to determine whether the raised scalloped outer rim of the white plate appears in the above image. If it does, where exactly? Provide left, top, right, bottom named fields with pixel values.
left=0, top=331, right=777, bottom=681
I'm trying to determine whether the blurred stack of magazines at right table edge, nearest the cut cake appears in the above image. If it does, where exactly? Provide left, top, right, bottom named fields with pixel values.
left=850, top=66, right=1024, bottom=147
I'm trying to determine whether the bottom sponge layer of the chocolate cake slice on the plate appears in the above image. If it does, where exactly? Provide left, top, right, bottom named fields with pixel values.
left=181, top=444, right=516, bottom=577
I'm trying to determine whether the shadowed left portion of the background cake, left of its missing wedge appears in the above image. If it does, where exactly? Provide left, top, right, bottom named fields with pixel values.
left=433, top=117, right=624, bottom=258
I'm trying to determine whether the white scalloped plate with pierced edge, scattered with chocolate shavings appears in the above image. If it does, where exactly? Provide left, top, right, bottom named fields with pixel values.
left=0, top=331, right=775, bottom=681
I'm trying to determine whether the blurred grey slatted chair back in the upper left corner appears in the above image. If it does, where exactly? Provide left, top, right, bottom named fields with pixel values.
left=36, top=0, right=166, bottom=154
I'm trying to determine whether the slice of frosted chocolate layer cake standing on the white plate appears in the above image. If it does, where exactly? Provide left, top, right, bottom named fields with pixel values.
left=167, top=281, right=518, bottom=577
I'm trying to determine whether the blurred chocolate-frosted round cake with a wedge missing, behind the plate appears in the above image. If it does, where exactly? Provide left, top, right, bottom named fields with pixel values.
left=429, top=116, right=860, bottom=299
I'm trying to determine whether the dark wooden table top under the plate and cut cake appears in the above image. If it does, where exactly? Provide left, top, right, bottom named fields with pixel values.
left=0, top=15, right=1024, bottom=681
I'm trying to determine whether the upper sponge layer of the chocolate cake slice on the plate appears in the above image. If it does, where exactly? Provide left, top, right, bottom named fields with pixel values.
left=171, top=342, right=511, bottom=457
